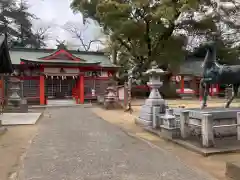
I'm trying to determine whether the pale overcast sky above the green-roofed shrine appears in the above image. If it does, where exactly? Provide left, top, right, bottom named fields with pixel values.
left=27, top=0, right=104, bottom=50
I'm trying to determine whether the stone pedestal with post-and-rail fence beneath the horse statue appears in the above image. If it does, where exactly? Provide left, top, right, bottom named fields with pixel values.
left=174, top=108, right=240, bottom=150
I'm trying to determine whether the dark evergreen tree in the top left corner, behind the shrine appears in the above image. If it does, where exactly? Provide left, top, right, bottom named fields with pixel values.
left=0, top=0, right=43, bottom=48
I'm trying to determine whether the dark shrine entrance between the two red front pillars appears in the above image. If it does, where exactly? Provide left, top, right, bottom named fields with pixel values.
left=45, top=76, right=77, bottom=99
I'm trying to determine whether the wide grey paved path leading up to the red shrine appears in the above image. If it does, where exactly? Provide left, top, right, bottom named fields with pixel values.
left=20, top=107, right=216, bottom=180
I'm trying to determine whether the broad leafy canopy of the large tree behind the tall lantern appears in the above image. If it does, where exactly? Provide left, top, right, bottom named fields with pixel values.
left=71, top=0, right=239, bottom=97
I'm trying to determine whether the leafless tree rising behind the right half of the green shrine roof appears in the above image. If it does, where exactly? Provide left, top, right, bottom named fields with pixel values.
left=63, top=22, right=104, bottom=51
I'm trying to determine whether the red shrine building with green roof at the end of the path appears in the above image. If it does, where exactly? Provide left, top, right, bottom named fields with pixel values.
left=10, top=47, right=118, bottom=105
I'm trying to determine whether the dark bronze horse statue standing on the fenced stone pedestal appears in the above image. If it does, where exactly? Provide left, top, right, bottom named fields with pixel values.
left=200, top=41, right=240, bottom=109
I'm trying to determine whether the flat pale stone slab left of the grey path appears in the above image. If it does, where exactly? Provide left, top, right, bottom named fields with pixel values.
left=0, top=113, right=42, bottom=126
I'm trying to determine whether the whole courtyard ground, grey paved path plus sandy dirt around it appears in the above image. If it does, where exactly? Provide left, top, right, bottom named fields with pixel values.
left=0, top=100, right=240, bottom=180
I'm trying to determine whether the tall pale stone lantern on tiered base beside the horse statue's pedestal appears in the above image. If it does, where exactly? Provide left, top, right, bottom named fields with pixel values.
left=136, top=67, right=167, bottom=126
